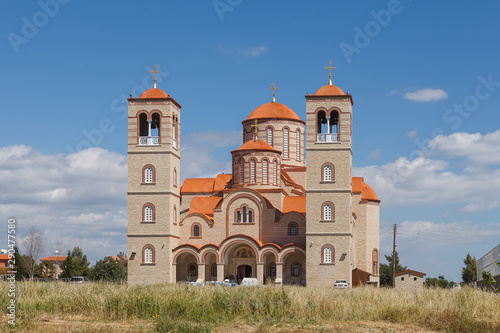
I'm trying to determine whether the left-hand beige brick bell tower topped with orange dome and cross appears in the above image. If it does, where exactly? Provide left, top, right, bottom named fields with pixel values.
left=127, top=66, right=181, bottom=284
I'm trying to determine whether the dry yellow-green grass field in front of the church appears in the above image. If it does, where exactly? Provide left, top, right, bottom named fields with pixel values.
left=0, top=282, right=500, bottom=333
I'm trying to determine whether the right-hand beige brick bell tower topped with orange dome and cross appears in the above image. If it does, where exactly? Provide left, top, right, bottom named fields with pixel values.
left=305, top=61, right=354, bottom=286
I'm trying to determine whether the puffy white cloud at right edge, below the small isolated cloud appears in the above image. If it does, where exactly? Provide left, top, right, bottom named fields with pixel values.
left=429, top=130, right=500, bottom=165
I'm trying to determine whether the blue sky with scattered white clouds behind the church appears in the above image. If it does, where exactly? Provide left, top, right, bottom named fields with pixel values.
left=0, top=0, right=500, bottom=281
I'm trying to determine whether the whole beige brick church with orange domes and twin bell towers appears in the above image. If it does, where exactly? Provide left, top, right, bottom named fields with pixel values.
left=127, top=62, right=380, bottom=286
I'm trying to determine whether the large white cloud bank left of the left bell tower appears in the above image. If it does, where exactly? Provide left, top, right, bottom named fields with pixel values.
left=0, top=145, right=127, bottom=260
